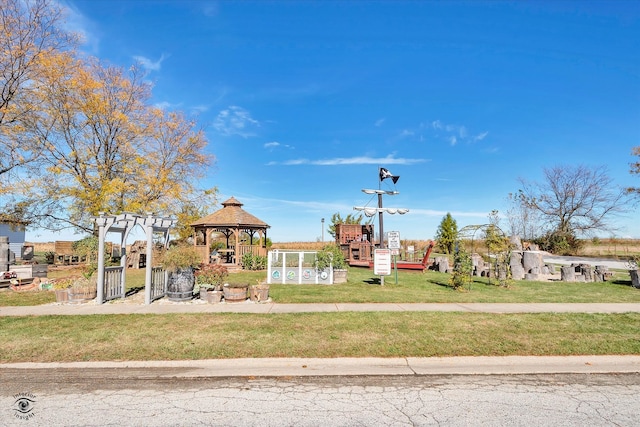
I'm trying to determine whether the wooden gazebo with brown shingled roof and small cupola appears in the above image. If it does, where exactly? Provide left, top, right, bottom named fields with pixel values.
left=191, top=197, right=269, bottom=268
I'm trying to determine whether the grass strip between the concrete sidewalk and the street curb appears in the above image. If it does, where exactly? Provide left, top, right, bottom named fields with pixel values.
left=0, top=312, right=640, bottom=363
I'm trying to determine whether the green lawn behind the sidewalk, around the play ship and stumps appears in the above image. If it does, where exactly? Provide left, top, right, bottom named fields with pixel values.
left=0, top=268, right=640, bottom=306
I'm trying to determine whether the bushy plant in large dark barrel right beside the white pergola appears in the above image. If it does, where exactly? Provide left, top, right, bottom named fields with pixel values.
left=160, top=244, right=201, bottom=301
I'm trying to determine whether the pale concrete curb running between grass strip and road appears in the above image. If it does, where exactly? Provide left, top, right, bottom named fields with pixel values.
left=0, top=355, right=640, bottom=378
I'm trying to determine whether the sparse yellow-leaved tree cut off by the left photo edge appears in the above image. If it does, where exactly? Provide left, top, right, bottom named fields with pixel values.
left=0, top=0, right=78, bottom=223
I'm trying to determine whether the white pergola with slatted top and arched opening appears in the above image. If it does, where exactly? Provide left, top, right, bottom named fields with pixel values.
left=93, top=212, right=176, bottom=304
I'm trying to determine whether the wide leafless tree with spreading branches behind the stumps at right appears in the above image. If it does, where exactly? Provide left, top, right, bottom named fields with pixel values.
left=520, top=165, right=625, bottom=236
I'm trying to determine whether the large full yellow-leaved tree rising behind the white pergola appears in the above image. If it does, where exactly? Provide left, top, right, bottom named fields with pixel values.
left=21, top=54, right=215, bottom=231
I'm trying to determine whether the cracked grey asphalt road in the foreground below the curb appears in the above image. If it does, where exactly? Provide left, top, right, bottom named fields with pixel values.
left=0, top=368, right=640, bottom=427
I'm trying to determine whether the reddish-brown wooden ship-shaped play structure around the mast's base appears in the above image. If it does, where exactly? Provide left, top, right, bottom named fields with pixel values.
left=336, top=224, right=436, bottom=271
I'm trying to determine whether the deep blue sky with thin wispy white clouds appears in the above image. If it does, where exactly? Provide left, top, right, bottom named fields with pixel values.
left=27, top=0, right=640, bottom=242
